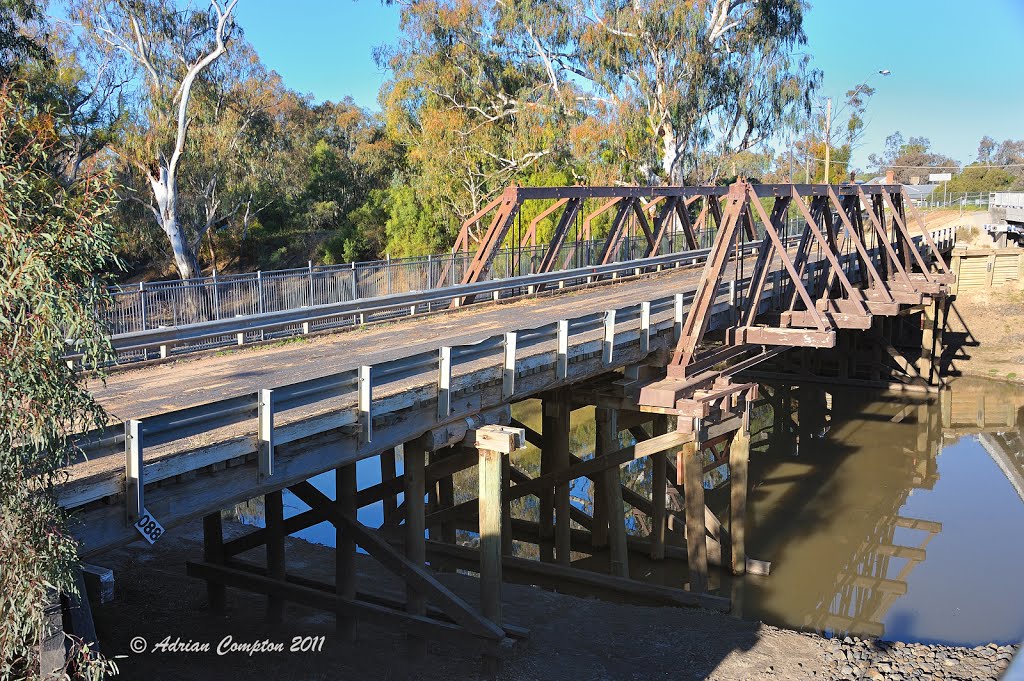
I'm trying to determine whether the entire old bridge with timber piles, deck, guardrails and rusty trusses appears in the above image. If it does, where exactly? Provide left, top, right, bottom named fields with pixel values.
left=58, top=182, right=955, bottom=659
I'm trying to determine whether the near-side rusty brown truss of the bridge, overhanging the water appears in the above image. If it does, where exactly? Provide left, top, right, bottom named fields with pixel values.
left=640, top=181, right=955, bottom=418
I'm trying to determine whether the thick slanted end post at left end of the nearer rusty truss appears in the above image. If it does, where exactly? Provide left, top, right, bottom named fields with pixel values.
left=669, top=182, right=746, bottom=378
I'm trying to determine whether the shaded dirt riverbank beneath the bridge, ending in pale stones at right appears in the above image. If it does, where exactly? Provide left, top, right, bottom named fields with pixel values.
left=88, top=522, right=1013, bottom=681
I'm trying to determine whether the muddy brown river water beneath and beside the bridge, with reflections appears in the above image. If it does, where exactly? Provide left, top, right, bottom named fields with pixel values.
left=240, top=379, right=1024, bottom=645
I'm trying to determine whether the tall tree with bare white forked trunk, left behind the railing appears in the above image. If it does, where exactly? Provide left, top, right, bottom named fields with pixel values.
left=73, top=0, right=238, bottom=279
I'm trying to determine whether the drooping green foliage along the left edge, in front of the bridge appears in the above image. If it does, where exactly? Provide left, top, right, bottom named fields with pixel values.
left=0, top=84, right=115, bottom=679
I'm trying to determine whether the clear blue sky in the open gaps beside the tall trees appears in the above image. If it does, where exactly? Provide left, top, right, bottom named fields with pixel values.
left=237, top=0, right=1024, bottom=165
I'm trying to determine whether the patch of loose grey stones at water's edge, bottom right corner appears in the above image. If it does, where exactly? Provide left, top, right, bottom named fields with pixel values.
left=818, top=637, right=1017, bottom=681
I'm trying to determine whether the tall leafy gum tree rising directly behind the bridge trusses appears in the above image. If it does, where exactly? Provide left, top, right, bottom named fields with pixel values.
left=524, top=0, right=819, bottom=183
